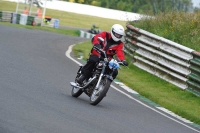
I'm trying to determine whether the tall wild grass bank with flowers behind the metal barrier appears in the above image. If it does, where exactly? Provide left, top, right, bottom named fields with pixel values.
left=130, top=11, right=200, bottom=51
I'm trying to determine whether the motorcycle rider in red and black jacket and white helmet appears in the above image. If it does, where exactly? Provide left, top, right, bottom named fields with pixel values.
left=77, top=24, right=128, bottom=85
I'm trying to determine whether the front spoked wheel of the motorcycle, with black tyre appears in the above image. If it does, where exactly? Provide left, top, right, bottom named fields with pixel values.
left=90, top=78, right=112, bottom=105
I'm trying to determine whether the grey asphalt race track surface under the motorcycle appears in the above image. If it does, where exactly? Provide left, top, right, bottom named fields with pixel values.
left=0, top=25, right=197, bottom=133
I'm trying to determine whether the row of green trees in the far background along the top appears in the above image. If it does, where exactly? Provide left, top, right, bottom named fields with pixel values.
left=64, top=0, right=198, bottom=14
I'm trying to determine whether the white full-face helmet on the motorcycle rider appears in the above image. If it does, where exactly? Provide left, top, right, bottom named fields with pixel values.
left=110, top=24, right=124, bottom=42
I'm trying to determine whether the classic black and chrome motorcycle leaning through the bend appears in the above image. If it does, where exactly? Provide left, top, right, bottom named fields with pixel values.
left=70, top=37, right=124, bottom=105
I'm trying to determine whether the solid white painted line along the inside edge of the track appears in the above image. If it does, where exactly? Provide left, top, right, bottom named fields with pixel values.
left=65, top=44, right=200, bottom=133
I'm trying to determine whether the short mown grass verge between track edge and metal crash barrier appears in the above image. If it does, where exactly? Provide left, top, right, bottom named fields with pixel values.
left=73, top=41, right=200, bottom=124
